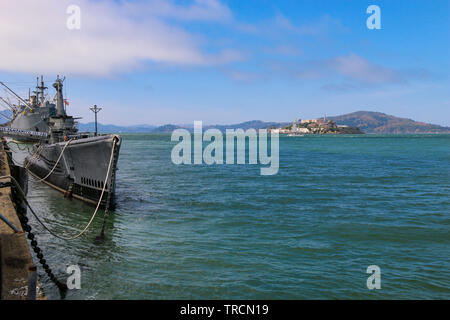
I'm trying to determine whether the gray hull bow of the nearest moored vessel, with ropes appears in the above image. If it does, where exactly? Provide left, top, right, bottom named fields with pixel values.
left=24, top=135, right=121, bottom=208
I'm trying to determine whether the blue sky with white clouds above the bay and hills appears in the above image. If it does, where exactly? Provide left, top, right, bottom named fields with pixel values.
left=0, top=0, right=450, bottom=126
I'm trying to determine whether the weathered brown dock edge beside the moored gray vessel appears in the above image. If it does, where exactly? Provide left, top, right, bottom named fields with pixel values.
left=0, top=138, right=43, bottom=300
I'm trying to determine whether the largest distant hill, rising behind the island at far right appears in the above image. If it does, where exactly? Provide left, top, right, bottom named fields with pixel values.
left=327, top=111, right=450, bottom=133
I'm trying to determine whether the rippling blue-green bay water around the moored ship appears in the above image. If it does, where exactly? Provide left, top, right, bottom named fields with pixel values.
left=7, top=135, right=450, bottom=299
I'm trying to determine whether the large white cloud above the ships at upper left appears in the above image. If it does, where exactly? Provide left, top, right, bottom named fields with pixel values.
left=0, top=0, right=242, bottom=76
